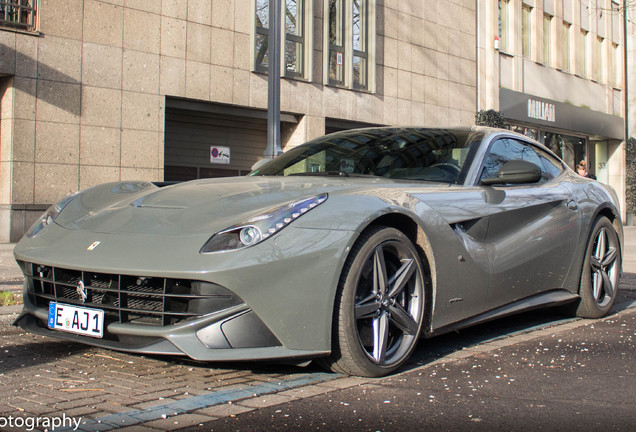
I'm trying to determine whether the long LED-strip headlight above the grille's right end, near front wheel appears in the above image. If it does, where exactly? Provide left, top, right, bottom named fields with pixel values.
left=200, top=193, right=328, bottom=253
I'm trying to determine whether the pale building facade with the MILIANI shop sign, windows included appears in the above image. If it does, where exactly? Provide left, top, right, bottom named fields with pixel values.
left=476, top=0, right=633, bottom=217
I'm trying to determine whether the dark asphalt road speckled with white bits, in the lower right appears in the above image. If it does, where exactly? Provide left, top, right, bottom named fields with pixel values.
left=182, top=309, right=636, bottom=431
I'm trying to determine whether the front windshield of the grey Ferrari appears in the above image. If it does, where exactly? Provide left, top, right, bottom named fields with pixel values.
left=250, top=128, right=482, bottom=184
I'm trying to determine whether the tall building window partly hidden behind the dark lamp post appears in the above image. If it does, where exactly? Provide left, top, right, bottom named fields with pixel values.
left=254, top=0, right=311, bottom=78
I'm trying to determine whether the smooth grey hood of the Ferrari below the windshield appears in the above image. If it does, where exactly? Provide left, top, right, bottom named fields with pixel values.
left=56, top=176, right=448, bottom=236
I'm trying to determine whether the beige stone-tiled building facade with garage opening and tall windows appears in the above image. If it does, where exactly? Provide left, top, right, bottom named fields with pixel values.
left=0, top=0, right=477, bottom=242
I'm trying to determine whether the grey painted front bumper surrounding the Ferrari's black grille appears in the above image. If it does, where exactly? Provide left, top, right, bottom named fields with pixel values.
left=15, top=224, right=355, bottom=361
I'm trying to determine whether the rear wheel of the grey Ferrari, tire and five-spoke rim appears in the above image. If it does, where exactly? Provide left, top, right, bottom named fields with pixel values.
left=576, top=216, right=622, bottom=318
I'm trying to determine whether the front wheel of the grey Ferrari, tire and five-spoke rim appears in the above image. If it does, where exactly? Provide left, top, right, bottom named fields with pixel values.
left=320, top=227, right=426, bottom=377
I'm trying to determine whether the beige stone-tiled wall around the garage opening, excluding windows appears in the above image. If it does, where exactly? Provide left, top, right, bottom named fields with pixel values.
left=0, top=0, right=476, bottom=240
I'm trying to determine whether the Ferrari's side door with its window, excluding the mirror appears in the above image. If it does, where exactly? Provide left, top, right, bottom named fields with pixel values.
left=479, top=138, right=580, bottom=309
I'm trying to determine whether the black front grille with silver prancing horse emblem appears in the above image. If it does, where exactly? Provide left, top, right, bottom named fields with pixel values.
left=21, top=263, right=242, bottom=326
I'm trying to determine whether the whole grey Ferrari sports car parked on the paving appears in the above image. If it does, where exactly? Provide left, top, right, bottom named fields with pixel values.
left=15, top=127, right=623, bottom=376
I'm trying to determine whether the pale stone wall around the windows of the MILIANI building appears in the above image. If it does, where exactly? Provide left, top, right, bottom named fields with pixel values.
left=477, top=0, right=633, bottom=216
